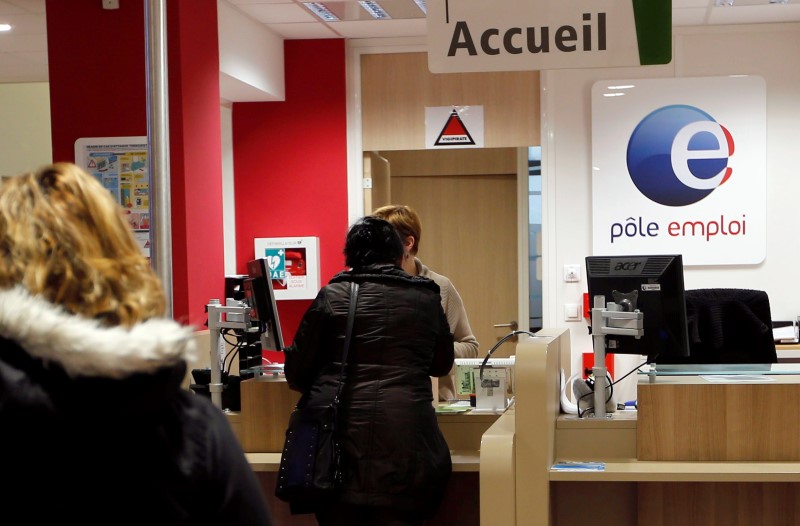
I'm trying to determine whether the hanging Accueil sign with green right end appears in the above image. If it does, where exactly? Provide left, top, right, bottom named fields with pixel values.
left=427, top=0, right=672, bottom=73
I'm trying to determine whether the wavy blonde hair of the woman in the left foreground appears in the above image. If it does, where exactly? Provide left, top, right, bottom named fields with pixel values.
left=0, top=163, right=165, bottom=326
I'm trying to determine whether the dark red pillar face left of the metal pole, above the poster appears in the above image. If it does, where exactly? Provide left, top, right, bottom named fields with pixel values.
left=46, top=0, right=147, bottom=162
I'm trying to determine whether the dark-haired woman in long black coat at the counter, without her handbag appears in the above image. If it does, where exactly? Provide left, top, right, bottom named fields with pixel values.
left=285, top=217, right=453, bottom=526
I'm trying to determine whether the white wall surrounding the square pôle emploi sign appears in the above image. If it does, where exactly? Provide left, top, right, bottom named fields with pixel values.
left=541, top=23, right=800, bottom=400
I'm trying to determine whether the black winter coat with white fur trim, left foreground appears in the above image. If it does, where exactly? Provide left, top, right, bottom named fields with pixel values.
left=0, top=288, right=272, bottom=526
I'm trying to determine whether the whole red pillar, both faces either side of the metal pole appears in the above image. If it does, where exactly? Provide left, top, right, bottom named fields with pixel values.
left=46, top=0, right=224, bottom=328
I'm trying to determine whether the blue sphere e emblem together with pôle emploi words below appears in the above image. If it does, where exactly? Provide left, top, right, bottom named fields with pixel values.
left=611, top=104, right=746, bottom=243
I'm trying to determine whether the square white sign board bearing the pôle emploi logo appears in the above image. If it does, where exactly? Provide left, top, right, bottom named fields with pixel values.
left=592, top=76, right=767, bottom=265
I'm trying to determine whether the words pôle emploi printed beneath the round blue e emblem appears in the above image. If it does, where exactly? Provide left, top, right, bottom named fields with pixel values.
left=610, top=214, right=747, bottom=243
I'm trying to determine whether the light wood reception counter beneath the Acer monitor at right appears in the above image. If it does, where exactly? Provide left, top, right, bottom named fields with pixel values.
left=480, top=331, right=800, bottom=526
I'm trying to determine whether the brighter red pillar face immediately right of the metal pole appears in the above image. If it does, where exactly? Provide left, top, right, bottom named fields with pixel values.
left=167, top=0, right=225, bottom=328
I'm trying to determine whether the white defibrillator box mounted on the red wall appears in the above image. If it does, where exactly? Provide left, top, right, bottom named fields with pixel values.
left=255, top=237, right=319, bottom=300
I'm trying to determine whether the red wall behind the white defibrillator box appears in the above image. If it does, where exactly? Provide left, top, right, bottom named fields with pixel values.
left=228, top=39, right=348, bottom=352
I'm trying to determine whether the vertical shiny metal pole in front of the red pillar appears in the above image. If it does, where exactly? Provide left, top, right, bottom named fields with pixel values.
left=144, top=0, right=173, bottom=318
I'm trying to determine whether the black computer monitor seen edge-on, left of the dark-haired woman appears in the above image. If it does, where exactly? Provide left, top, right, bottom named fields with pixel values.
left=244, top=258, right=283, bottom=351
